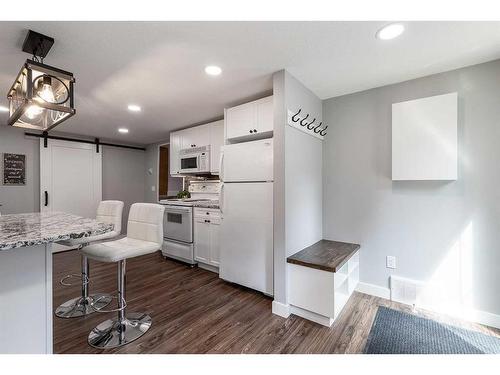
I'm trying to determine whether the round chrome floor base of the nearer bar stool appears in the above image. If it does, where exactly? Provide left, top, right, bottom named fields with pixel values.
left=88, top=313, right=152, bottom=349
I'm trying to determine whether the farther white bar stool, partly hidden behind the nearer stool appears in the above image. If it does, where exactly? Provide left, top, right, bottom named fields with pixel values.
left=55, top=200, right=123, bottom=318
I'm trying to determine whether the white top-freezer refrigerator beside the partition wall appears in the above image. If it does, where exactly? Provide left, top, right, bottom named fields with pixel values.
left=219, top=138, right=273, bottom=295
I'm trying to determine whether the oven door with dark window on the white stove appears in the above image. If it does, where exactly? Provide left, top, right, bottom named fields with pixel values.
left=163, top=205, right=193, bottom=243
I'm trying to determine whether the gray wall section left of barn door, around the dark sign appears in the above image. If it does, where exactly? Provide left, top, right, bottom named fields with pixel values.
left=0, top=124, right=40, bottom=214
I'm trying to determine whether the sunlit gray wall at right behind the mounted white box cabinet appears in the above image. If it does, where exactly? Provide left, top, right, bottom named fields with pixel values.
left=323, top=61, right=500, bottom=314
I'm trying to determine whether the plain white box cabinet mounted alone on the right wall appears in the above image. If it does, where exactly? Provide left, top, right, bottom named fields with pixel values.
left=392, top=93, right=458, bottom=180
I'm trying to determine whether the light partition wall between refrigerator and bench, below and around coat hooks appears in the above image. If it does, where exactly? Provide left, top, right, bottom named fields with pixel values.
left=273, top=71, right=323, bottom=304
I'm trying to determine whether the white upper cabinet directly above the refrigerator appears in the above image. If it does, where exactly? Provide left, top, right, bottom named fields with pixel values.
left=225, top=96, right=274, bottom=141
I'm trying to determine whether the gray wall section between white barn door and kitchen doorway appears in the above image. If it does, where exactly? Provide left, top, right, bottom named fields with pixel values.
left=102, top=146, right=146, bottom=233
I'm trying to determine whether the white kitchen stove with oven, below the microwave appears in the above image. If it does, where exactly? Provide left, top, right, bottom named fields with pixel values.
left=160, top=181, right=220, bottom=264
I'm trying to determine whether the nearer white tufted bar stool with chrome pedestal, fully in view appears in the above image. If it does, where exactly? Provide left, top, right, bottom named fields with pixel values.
left=82, top=203, right=165, bottom=349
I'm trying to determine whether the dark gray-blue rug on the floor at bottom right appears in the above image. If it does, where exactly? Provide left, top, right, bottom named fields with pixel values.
left=364, top=306, right=500, bottom=354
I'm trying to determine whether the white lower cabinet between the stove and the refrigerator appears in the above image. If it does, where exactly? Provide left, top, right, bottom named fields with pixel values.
left=194, top=208, right=221, bottom=271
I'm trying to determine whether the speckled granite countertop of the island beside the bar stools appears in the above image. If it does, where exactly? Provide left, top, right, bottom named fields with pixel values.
left=0, top=212, right=114, bottom=250
